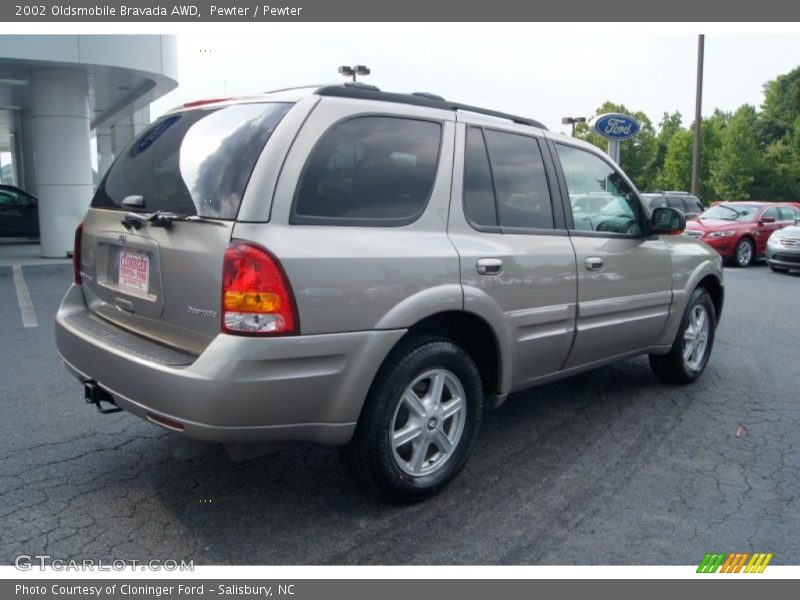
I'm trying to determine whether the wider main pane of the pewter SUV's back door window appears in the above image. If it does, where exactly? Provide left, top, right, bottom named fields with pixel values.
left=484, top=130, right=554, bottom=229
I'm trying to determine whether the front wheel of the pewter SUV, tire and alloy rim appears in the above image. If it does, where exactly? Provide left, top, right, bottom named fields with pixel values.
left=650, top=288, right=717, bottom=384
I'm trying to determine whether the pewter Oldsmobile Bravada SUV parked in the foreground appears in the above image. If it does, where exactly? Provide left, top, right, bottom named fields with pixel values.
left=56, top=85, right=723, bottom=502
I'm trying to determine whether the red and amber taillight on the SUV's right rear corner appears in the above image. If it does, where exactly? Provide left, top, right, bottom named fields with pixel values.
left=222, top=240, right=299, bottom=335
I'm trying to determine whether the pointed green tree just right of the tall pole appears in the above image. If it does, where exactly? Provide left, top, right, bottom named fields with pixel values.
left=710, top=104, right=766, bottom=200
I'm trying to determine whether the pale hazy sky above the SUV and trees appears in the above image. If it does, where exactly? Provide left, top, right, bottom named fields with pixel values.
left=151, top=24, right=800, bottom=131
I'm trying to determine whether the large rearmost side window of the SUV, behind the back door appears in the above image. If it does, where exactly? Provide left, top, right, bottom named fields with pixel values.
left=291, top=117, right=442, bottom=225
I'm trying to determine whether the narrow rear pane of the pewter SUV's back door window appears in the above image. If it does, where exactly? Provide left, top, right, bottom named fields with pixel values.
left=464, top=127, right=498, bottom=227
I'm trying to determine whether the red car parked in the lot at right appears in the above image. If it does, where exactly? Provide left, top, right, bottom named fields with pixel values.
left=684, top=201, right=796, bottom=267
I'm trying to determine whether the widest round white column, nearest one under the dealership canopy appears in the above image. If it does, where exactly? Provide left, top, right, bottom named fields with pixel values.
left=31, top=69, right=92, bottom=258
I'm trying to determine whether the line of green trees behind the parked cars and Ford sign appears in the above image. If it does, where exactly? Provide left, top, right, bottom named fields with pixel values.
left=575, top=67, right=800, bottom=203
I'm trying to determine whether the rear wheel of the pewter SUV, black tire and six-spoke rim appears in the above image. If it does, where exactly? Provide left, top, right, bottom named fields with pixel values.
left=339, top=337, right=483, bottom=503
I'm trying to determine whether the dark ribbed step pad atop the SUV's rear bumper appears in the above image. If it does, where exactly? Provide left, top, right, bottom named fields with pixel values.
left=65, top=312, right=197, bottom=367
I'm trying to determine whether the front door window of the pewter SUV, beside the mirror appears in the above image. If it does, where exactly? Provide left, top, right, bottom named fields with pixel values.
left=556, top=144, right=643, bottom=235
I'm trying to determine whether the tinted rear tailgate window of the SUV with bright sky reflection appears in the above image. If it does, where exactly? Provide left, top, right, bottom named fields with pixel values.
left=92, top=103, right=292, bottom=219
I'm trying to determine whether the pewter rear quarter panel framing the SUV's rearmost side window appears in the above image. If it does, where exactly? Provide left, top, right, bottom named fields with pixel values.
left=233, top=98, right=463, bottom=334
